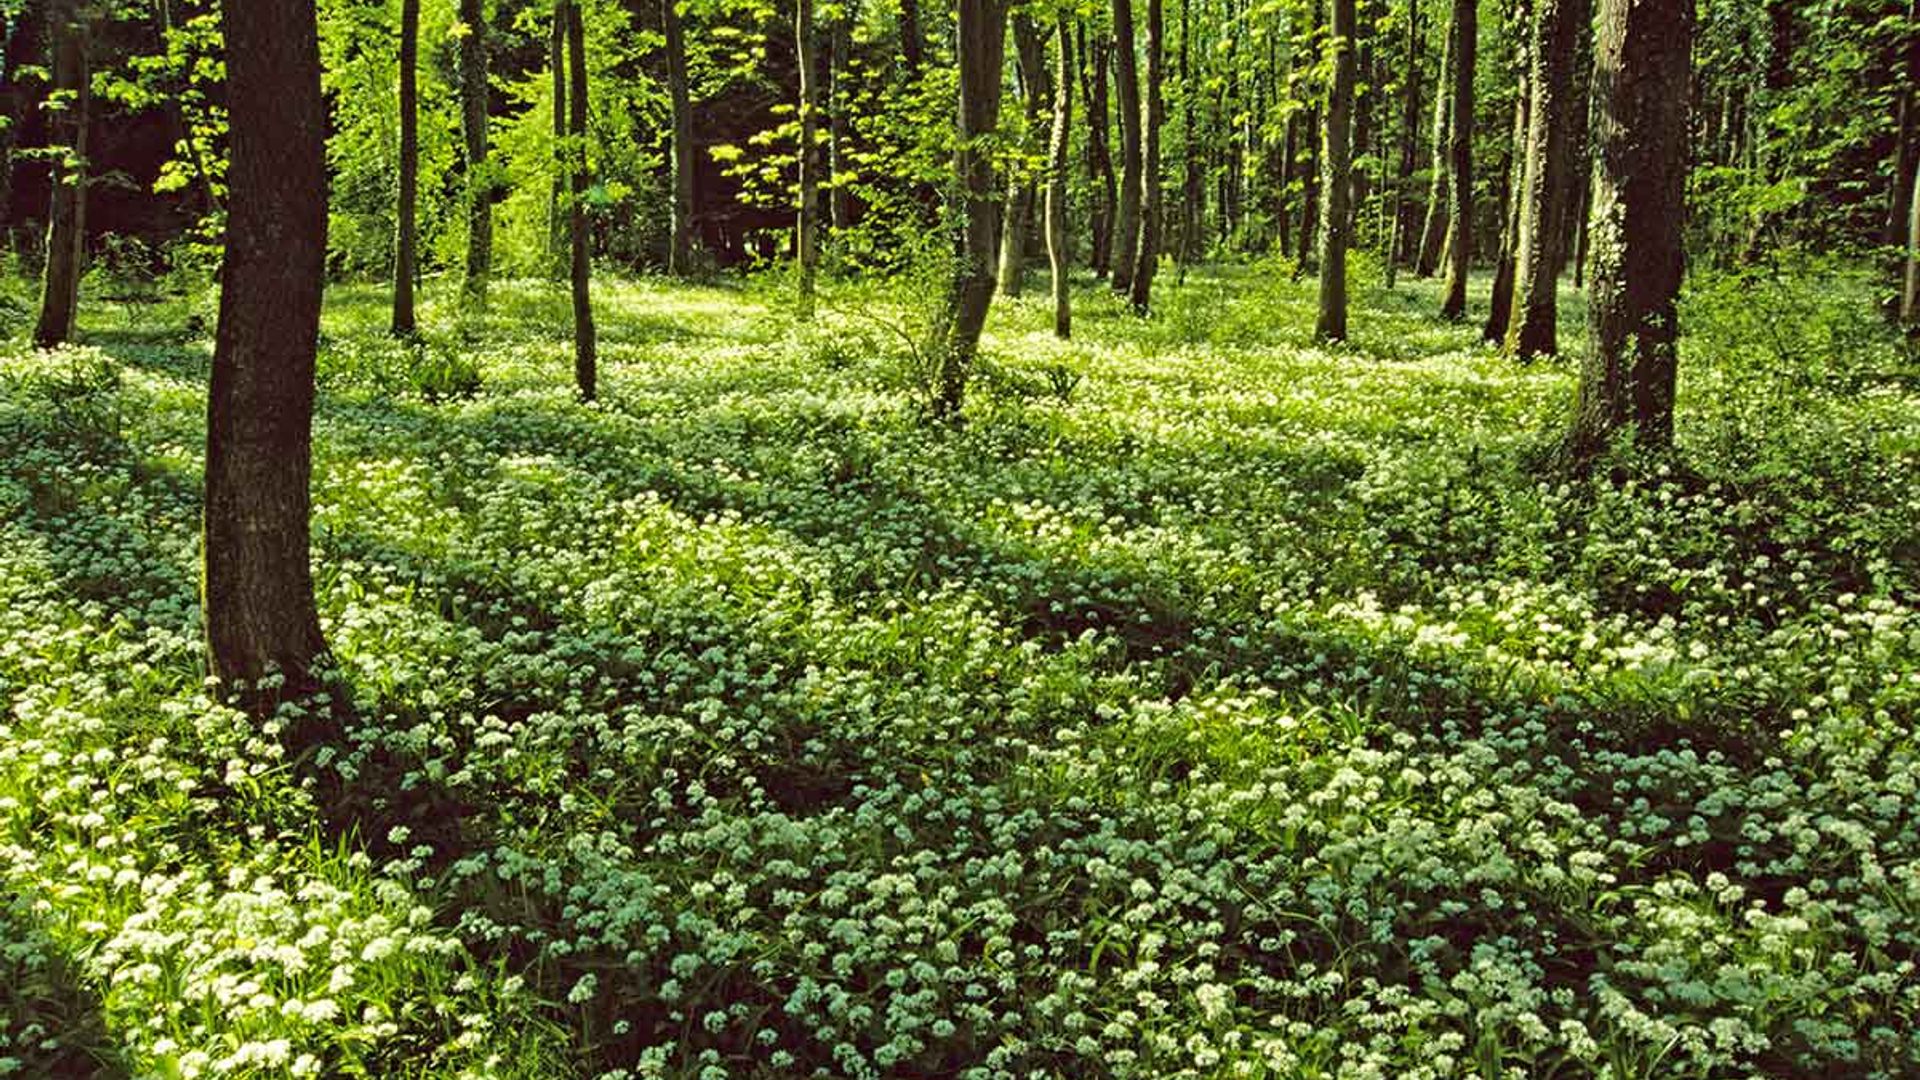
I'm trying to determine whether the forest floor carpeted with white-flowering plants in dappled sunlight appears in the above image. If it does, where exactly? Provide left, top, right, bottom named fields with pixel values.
left=0, top=267, right=1920, bottom=1078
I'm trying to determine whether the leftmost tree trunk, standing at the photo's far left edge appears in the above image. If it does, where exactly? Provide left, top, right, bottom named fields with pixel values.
left=33, top=0, right=92, bottom=348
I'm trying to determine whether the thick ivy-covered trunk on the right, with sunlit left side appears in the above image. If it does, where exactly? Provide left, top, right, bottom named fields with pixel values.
left=1567, top=0, right=1693, bottom=469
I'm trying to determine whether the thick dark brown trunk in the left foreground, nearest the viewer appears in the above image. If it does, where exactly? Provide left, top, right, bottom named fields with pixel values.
left=202, top=0, right=326, bottom=717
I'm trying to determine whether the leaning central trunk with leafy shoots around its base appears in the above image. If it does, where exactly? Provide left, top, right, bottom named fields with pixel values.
left=933, top=0, right=1006, bottom=423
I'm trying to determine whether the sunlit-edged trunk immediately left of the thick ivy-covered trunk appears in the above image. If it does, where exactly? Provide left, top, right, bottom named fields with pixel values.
left=1507, top=0, right=1590, bottom=359
